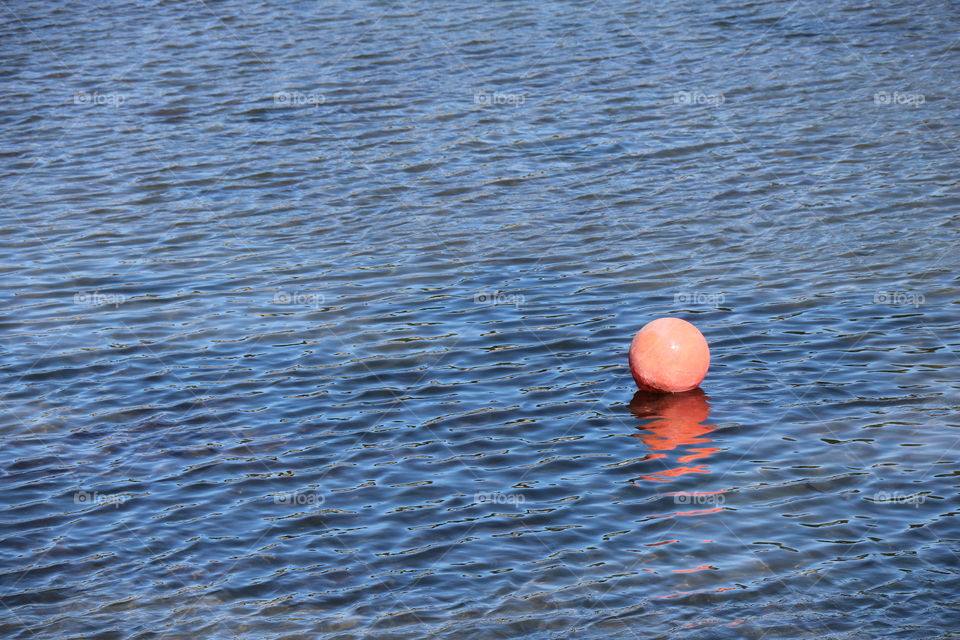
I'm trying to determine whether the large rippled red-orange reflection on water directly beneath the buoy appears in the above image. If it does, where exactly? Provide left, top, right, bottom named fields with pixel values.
left=630, top=387, right=719, bottom=482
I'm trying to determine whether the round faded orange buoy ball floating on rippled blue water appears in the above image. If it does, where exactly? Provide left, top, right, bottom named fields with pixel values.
left=628, top=318, right=710, bottom=393
